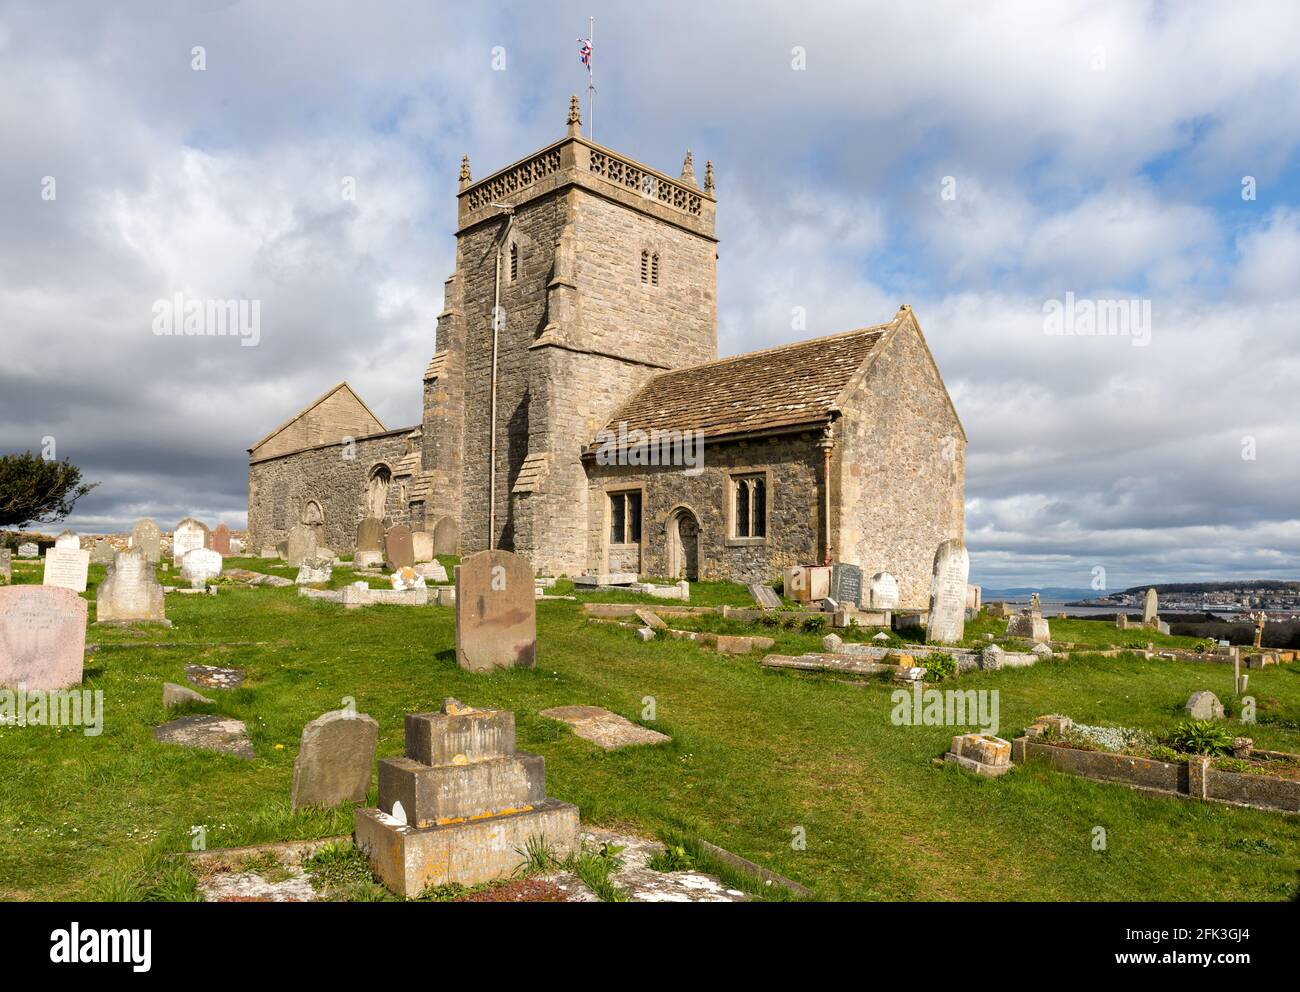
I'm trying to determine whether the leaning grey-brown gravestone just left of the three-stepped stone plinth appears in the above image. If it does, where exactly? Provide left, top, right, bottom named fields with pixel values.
left=291, top=710, right=380, bottom=810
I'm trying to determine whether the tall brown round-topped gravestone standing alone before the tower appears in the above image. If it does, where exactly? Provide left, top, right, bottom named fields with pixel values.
left=456, top=550, right=537, bottom=672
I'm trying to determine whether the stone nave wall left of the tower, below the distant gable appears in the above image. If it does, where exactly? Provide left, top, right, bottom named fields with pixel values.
left=248, top=428, right=411, bottom=554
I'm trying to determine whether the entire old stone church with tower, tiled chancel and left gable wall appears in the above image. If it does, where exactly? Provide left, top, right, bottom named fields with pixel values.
left=248, top=98, right=966, bottom=607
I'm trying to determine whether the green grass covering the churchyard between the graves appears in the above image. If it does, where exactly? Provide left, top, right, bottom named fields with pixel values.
left=0, top=559, right=1300, bottom=900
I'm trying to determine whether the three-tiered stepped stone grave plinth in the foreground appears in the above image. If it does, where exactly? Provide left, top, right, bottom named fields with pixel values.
left=356, top=699, right=579, bottom=898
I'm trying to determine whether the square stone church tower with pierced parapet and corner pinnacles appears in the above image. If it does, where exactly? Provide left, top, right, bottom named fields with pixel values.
left=413, top=98, right=718, bottom=575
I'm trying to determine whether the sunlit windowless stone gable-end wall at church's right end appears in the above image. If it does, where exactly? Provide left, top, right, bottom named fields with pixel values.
left=832, top=312, right=966, bottom=608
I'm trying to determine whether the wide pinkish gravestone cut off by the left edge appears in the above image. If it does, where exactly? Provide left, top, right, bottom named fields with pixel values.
left=0, top=585, right=86, bottom=690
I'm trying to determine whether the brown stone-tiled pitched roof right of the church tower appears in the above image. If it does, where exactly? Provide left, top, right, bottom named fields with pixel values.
left=589, top=322, right=893, bottom=450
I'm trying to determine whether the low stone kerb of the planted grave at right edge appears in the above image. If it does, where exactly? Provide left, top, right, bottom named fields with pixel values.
left=1011, top=715, right=1300, bottom=813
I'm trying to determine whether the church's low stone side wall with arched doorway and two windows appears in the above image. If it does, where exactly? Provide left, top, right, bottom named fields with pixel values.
left=588, top=432, right=822, bottom=582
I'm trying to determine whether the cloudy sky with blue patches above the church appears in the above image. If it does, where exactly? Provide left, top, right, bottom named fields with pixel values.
left=0, top=0, right=1300, bottom=588
